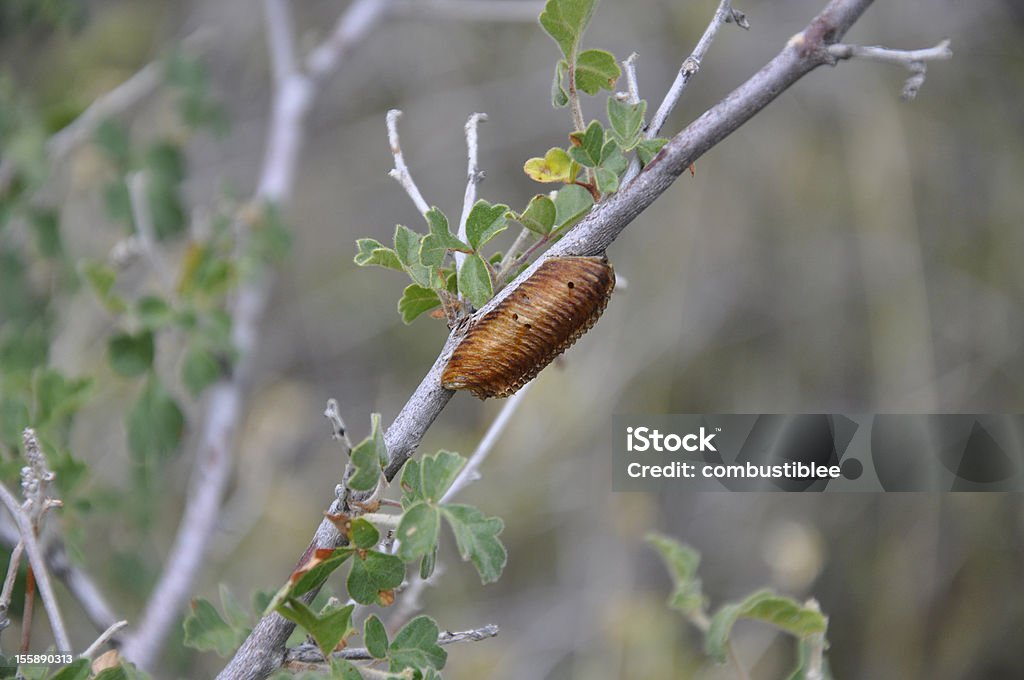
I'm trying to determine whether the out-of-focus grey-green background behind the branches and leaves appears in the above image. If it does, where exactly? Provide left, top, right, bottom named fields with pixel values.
left=0, top=0, right=1024, bottom=680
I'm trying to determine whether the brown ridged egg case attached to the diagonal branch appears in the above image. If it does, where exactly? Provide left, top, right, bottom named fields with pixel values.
left=441, top=257, right=615, bottom=399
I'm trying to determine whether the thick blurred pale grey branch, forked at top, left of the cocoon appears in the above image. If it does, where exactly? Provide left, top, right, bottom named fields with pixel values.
left=123, top=0, right=389, bottom=668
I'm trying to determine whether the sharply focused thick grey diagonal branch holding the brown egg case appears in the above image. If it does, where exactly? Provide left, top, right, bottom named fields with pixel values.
left=218, top=0, right=954, bottom=680
